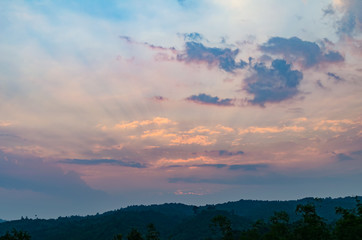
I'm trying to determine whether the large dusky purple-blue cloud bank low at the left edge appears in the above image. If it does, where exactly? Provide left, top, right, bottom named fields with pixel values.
left=0, top=151, right=103, bottom=198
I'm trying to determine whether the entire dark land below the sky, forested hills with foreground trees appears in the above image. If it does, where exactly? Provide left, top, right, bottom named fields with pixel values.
left=0, top=197, right=362, bottom=240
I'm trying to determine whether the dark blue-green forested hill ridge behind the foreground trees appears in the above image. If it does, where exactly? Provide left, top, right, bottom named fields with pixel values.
left=0, top=197, right=361, bottom=240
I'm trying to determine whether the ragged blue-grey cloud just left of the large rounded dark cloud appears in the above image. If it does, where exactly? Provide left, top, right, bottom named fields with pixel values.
left=177, top=41, right=247, bottom=72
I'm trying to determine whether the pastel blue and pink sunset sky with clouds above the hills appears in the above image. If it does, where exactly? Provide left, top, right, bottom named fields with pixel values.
left=0, top=0, right=362, bottom=220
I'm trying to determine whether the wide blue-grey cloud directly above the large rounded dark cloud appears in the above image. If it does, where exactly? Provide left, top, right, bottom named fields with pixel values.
left=260, top=37, right=344, bottom=68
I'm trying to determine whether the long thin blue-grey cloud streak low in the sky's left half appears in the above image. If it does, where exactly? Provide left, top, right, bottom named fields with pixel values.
left=59, top=159, right=147, bottom=168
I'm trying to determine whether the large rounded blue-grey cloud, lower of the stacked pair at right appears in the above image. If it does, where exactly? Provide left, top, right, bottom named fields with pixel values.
left=244, top=59, right=303, bottom=106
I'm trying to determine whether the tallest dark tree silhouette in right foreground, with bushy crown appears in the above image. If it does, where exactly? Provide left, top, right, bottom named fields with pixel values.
left=294, top=204, right=331, bottom=240
